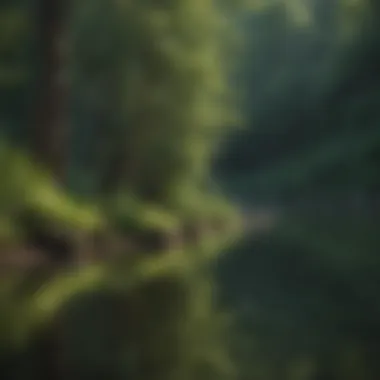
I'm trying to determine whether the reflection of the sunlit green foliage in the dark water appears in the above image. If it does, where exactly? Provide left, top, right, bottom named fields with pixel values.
left=0, top=254, right=233, bottom=379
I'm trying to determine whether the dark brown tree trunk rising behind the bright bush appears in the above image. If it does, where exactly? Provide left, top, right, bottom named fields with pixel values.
left=32, top=0, right=69, bottom=181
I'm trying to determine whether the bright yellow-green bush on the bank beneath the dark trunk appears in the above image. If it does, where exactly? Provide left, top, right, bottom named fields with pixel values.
left=0, top=144, right=103, bottom=238
